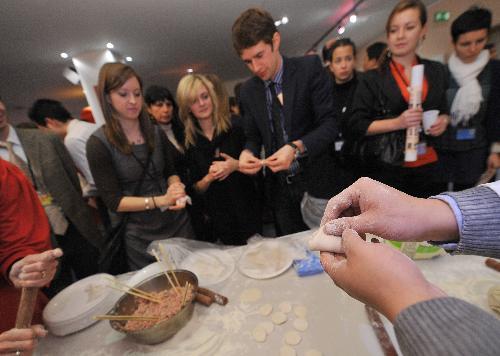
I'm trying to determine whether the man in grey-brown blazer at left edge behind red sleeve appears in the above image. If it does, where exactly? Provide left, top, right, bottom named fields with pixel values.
left=0, top=100, right=103, bottom=291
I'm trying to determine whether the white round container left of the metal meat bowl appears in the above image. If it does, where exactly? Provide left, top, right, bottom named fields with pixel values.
left=43, top=273, right=123, bottom=336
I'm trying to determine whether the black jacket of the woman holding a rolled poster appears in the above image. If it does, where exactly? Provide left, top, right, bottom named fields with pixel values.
left=344, top=59, right=449, bottom=140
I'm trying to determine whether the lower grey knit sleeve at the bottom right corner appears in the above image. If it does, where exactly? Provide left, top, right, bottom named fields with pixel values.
left=394, top=297, right=500, bottom=356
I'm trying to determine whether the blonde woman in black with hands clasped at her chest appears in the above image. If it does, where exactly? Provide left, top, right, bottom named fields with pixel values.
left=177, top=74, right=262, bottom=245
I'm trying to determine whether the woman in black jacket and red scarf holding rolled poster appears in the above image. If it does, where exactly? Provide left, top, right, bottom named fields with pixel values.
left=344, top=0, right=448, bottom=197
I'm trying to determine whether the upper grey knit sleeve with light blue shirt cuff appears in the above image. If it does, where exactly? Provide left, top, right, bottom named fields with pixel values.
left=442, top=186, right=500, bottom=258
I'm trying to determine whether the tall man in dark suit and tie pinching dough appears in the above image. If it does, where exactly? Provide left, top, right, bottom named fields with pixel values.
left=232, top=8, right=337, bottom=235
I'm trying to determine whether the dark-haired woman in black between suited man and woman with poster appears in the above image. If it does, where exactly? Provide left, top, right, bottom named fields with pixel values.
left=301, top=38, right=359, bottom=228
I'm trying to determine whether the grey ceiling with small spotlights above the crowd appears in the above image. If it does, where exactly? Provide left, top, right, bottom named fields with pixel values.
left=0, top=0, right=435, bottom=121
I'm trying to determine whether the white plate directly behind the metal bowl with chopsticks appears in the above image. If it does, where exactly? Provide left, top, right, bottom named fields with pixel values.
left=180, top=249, right=235, bottom=287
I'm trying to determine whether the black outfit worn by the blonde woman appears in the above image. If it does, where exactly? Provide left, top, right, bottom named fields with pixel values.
left=186, top=127, right=262, bottom=245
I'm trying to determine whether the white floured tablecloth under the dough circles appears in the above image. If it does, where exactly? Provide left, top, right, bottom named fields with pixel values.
left=37, top=232, right=500, bottom=356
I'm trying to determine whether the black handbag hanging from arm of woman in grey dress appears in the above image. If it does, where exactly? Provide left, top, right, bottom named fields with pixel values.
left=98, top=153, right=151, bottom=275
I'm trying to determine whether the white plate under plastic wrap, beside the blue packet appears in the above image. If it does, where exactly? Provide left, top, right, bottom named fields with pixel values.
left=238, top=240, right=294, bottom=279
